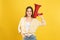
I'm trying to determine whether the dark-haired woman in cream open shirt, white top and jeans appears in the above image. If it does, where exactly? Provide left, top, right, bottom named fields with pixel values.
left=18, top=6, right=46, bottom=40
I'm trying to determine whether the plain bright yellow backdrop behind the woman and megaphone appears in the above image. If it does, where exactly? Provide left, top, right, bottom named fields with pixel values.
left=0, top=0, right=60, bottom=40
